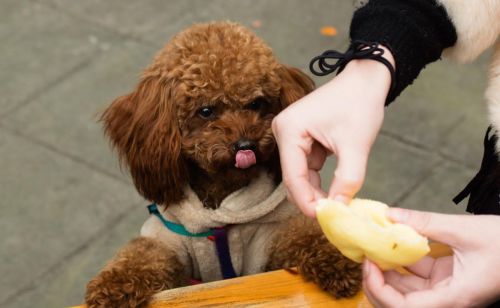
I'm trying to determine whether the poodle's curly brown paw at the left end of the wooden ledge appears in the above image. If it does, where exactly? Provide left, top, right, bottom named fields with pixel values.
left=85, top=270, right=152, bottom=308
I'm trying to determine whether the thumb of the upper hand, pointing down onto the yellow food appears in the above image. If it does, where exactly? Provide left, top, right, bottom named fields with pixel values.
left=328, top=151, right=368, bottom=204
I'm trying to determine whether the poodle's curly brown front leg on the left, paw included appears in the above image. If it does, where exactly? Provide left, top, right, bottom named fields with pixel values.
left=85, top=237, right=186, bottom=308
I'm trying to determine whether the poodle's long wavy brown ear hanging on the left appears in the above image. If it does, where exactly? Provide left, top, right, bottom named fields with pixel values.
left=101, top=76, right=188, bottom=206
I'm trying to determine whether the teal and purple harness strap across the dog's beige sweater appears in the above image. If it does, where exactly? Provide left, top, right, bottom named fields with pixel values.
left=148, top=203, right=236, bottom=279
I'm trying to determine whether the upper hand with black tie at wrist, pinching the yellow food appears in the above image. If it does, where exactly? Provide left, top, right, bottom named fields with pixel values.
left=273, top=50, right=394, bottom=217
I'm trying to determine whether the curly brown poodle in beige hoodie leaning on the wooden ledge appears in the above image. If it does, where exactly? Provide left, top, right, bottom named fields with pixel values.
left=85, top=22, right=361, bottom=307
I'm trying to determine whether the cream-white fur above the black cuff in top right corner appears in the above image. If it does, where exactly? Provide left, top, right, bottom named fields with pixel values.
left=438, top=0, right=500, bottom=62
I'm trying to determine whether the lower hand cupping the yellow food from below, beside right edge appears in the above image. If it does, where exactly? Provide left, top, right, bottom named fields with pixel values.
left=363, top=209, right=500, bottom=308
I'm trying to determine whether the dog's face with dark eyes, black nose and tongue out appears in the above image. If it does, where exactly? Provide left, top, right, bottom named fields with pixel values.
left=180, top=95, right=281, bottom=174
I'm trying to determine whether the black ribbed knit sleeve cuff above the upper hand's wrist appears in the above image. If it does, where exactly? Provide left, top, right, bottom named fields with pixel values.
left=350, top=0, right=457, bottom=103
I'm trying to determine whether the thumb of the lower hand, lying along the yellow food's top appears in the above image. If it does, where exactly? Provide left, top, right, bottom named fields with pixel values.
left=387, top=208, right=470, bottom=248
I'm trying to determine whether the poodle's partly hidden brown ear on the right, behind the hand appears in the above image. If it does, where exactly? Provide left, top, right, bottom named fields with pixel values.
left=279, top=65, right=315, bottom=109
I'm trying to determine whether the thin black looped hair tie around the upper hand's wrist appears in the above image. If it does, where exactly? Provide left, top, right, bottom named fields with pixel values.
left=309, top=40, right=396, bottom=91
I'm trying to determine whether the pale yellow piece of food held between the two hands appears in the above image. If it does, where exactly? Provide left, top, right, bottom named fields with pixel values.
left=316, top=199, right=430, bottom=270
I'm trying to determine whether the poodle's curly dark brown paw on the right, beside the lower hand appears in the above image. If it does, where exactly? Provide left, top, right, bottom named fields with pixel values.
left=298, top=239, right=362, bottom=298
